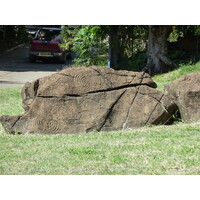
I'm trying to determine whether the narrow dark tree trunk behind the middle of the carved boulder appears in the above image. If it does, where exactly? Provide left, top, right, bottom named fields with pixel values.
left=109, top=26, right=119, bottom=69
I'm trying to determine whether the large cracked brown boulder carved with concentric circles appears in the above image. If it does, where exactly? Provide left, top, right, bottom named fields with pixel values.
left=0, top=67, right=177, bottom=134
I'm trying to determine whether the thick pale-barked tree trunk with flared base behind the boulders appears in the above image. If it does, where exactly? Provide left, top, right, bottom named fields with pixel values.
left=146, top=25, right=174, bottom=75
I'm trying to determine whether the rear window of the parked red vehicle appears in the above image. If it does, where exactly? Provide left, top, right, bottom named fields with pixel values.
left=35, top=29, right=62, bottom=41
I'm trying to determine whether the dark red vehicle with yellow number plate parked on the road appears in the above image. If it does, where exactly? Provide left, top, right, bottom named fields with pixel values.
left=29, top=27, right=69, bottom=63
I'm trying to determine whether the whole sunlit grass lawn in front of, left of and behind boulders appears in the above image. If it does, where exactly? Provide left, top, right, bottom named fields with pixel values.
left=0, top=63, right=200, bottom=175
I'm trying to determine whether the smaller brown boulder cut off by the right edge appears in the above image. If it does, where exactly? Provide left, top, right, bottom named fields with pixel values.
left=165, top=72, right=200, bottom=122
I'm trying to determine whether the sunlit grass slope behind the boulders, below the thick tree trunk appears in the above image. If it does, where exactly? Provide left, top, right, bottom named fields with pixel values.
left=152, top=62, right=200, bottom=91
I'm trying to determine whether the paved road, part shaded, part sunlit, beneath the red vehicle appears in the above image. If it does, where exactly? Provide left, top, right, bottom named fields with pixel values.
left=0, top=46, right=71, bottom=89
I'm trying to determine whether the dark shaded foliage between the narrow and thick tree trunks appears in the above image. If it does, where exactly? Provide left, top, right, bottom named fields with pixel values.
left=109, top=25, right=148, bottom=71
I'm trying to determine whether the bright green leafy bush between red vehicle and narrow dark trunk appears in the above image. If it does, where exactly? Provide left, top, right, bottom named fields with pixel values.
left=62, top=25, right=108, bottom=66
